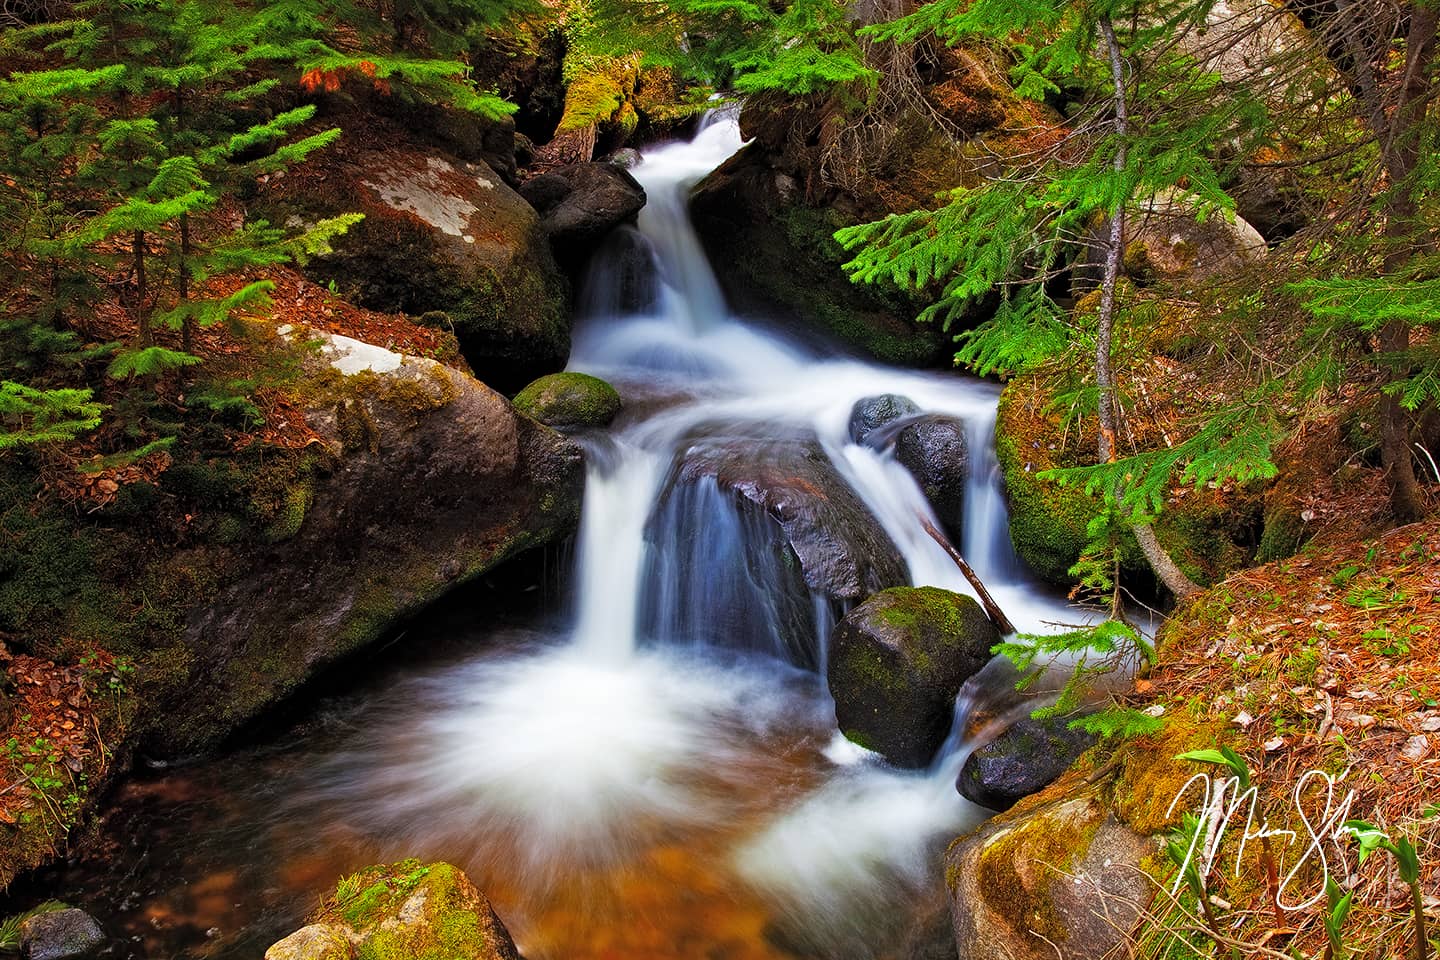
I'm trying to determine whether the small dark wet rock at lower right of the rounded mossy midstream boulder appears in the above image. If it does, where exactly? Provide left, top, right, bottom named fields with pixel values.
left=955, top=717, right=1097, bottom=810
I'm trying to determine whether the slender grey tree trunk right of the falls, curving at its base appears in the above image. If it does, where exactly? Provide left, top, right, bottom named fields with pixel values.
left=1094, top=17, right=1200, bottom=597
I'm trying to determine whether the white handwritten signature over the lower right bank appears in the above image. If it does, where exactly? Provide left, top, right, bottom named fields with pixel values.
left=1165, top=770, right=1355, bottom=911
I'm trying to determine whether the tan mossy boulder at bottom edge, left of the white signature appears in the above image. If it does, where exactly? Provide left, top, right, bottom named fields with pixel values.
left=945, top=793, right=1156, bottom=960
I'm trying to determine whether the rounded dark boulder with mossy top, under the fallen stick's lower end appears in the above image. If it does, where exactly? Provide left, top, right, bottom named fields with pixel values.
left=828, top=587, right=999, bottom=767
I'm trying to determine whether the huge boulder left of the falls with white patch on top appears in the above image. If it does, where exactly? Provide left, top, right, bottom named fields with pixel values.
left=160, top=330, right=585, bottom=753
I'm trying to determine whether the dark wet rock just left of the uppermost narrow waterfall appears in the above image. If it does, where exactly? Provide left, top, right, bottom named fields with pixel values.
left=521, top=163, right=645, bottom=256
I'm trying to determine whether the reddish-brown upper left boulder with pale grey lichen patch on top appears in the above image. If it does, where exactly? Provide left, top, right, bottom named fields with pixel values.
left=255, top=118, right=570, bottom=390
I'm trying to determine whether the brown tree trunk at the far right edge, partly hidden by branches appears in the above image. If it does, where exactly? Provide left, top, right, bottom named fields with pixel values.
left=1375, top=4, right=1437, bottom=524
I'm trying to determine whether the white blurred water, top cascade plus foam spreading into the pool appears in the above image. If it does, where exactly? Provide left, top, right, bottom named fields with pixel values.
left=295, top=110, right=1084, bottom=957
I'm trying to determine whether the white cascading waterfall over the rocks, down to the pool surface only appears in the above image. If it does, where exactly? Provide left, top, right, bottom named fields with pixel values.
left=570, top=111, right=1074, bottom=666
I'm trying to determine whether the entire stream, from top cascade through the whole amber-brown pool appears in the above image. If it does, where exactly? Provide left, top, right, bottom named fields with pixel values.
left=22, top=115, right=1081, bottom=960
